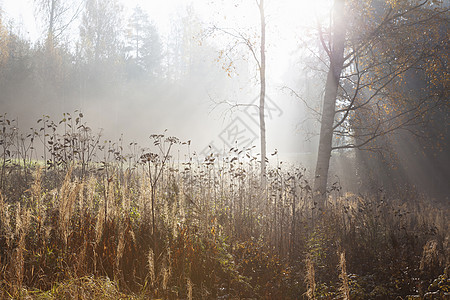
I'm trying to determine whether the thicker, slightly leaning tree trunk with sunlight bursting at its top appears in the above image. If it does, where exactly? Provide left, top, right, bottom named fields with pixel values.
left=314, top=0, right=345, bottom=208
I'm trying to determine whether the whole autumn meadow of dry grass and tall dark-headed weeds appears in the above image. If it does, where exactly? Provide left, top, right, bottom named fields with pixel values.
left=0, top=112, right=450, bottom=299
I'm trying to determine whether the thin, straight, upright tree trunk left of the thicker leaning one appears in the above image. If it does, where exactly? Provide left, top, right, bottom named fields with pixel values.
left=259, top=0, right=267, bottom=190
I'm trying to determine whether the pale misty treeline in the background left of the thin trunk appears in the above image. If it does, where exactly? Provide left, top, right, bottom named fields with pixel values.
left=0, top=0, right=236, bottom=144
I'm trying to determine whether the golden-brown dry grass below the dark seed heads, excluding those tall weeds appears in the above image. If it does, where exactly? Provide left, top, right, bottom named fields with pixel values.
left=0, top=163, right=449, bottom=299
